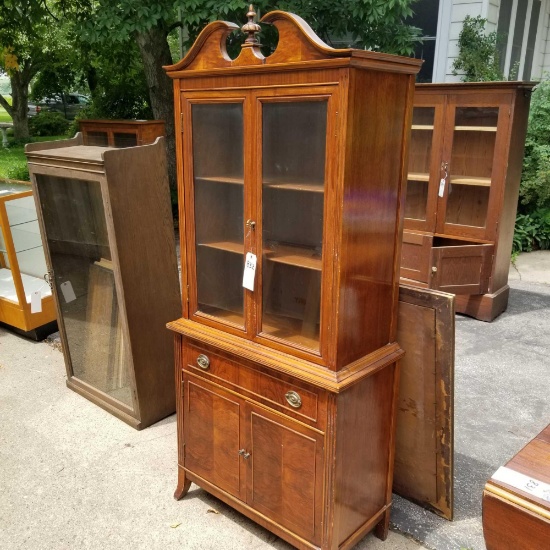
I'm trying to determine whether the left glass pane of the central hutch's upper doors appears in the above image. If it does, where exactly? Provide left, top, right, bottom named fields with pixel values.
left=192, top=103, right=244, bottom=326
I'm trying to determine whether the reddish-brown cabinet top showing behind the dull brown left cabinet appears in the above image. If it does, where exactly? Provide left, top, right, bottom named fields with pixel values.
left=78, top=119, right=164, bottom=147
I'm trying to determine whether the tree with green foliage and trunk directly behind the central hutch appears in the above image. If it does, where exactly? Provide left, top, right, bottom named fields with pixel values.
left=73, top=0, right=420, bottom=194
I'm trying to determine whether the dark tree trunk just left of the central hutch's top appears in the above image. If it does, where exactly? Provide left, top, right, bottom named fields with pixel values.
left=136, top=26, right=177, bottom=202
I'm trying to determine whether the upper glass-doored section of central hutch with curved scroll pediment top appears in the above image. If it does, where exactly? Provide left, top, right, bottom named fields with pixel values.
left=166, top=11, right=419, bottom=371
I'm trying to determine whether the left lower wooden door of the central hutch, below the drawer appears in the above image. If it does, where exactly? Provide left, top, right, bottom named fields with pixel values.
left=183, top=373, right=246, bottom=500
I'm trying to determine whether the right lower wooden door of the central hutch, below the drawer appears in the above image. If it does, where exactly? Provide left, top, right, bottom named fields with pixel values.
left=245, top=404, right=323, bottom=545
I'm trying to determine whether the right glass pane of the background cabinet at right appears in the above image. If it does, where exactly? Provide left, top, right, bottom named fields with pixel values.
left=445, top=107, right=498, bottom=227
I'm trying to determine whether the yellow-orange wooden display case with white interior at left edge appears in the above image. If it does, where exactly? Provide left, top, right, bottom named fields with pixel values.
left=0, top=182, right=56, bottom=340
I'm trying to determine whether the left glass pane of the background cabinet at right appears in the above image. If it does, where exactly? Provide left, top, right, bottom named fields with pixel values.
left=405, top=107, right=435, bottom=220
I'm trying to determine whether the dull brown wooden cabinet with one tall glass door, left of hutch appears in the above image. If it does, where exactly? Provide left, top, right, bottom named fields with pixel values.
left=26, top=133, right=181, bottom=429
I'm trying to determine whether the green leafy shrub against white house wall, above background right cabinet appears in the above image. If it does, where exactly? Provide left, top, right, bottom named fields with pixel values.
left=453, top=15, right=504, bottom=82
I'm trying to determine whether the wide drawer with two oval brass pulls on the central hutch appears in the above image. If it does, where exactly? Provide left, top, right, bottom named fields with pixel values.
left=183, top=343, right=326, bottom=429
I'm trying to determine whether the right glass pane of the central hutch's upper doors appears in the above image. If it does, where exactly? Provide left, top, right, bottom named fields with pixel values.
left=262, top=101, right=327, bottom=350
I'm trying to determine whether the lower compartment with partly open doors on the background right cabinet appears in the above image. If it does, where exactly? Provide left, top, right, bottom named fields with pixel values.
left=400, top=231, right=494, bottom=294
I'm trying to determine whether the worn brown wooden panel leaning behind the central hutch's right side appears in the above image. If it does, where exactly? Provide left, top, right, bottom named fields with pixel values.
left=393, top=285, right=454, bottom=519
